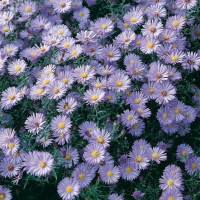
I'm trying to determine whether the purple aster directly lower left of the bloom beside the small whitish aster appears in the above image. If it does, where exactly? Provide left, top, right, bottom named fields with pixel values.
left=119, top=160, right=140, bottom=181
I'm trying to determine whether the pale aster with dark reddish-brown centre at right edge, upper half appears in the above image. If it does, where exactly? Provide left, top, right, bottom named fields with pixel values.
left=181, top=52, right=200, bottom=71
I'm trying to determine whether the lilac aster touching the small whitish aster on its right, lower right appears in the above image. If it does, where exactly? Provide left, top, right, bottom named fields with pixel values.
left=129, top=149, right=150, bottom=170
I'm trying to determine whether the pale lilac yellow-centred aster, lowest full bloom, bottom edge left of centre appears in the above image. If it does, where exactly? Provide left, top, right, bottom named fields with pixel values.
left=58, top=177, right=80, bottom=200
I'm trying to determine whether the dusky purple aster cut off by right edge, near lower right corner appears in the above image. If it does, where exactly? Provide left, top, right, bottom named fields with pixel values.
left=185, top=156, right=200, bottom=176
